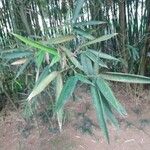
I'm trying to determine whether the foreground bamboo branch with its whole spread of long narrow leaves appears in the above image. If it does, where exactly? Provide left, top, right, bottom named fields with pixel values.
left=2, top=0, right=150, bottom=142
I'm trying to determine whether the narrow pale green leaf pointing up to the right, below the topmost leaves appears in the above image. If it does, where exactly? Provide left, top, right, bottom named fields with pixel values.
left=80, top=33, right=117, bottom=48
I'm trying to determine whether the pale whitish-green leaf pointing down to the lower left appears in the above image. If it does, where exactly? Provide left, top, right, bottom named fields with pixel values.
left=27, top=71, right=59, bottom=101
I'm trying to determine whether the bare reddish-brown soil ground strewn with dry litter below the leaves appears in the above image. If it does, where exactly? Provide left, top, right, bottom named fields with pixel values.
left=0, top=86, right=150, bottom=150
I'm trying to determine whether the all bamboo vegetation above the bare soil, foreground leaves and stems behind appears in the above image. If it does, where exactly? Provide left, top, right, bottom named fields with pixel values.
left=0, top=0, right=150, bottom=141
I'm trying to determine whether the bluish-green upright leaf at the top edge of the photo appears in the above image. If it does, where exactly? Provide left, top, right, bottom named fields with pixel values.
left=72, top=0, right=85, bottom=23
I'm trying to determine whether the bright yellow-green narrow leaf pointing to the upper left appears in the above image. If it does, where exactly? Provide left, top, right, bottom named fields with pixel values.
left=12, top=33, right=59, bottom=56
